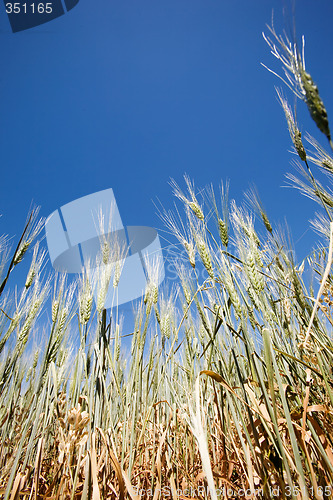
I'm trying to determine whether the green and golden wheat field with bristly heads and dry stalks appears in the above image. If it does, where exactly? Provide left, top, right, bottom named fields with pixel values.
left=0, top=19, right=333, bottom=500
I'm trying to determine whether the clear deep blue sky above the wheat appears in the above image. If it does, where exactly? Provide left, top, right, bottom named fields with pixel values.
left=0, top=0, right=333, bottom=298
